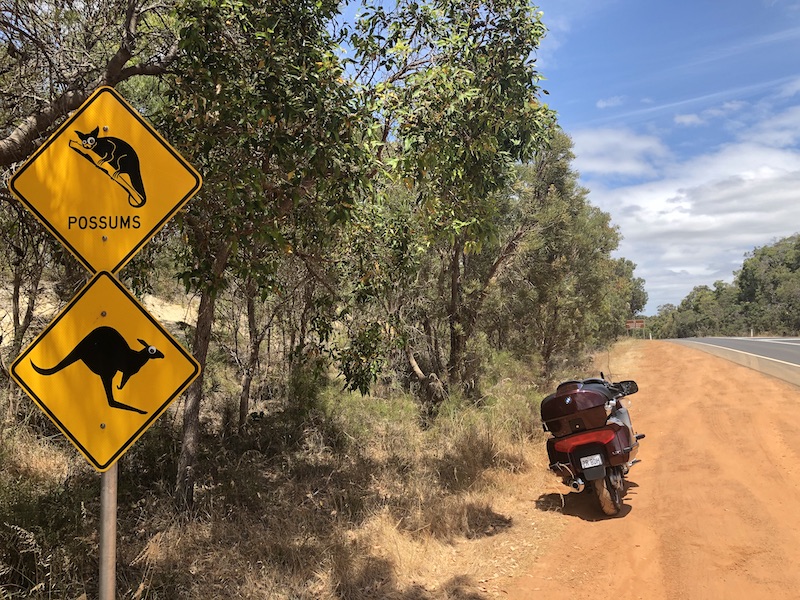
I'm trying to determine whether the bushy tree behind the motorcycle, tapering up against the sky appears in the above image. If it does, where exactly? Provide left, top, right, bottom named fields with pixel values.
left=481, top=132, right=647, bottom=377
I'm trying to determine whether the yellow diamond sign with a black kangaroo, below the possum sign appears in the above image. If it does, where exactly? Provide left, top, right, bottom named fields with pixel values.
left=11, top=272, right=200, bottom=472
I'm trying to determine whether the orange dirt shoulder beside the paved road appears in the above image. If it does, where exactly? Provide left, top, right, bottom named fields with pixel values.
left=499, top=341, right=800, bottom=600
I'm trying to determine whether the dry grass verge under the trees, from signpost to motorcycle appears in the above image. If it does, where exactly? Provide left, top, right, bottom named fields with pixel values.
left=0, top=350, right=576, bottom=600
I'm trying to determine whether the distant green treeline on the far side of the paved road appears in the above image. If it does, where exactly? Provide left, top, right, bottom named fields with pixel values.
left=648, top=234, right=800, bottom=338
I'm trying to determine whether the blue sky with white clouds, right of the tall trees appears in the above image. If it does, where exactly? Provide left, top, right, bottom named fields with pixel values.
left=534, top=0, right=800, bottom=314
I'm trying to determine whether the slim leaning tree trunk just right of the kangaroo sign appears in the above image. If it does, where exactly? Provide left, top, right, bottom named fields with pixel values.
left=175, top=247, right=230, bottom=510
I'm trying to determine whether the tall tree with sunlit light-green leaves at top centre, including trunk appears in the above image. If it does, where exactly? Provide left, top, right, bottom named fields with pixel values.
left=350, top=0, right=554, bottom=387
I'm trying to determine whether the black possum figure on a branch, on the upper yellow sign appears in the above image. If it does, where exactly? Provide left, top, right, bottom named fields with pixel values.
left=69, top=126, right=147, bottom=208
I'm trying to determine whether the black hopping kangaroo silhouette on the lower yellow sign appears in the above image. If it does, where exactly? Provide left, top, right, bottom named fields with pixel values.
left=31, top=326, right=164, bottom=415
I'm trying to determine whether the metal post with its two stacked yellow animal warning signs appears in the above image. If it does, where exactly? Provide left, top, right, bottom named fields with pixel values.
left=8, top=87, right=202, bottom=600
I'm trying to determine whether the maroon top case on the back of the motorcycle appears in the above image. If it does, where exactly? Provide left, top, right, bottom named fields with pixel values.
left=541, top=379, right=614, bottom=437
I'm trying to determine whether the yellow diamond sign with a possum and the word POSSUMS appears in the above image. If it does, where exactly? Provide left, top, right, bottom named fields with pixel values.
left=9, top=87, right=202, bottom=273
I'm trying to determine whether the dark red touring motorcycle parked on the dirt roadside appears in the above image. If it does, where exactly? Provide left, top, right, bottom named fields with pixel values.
left=541, top=373, right=644, bottom=516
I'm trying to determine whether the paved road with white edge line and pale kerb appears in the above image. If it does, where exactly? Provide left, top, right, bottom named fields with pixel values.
left=670, top=337, right=800, bottom=386
